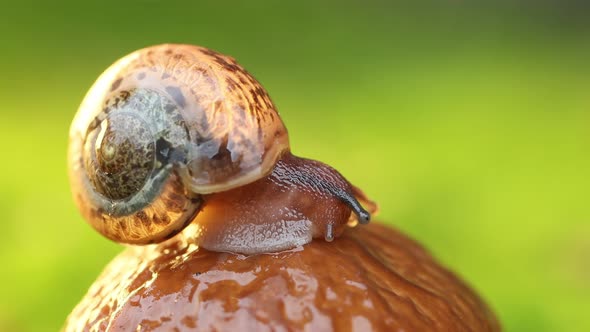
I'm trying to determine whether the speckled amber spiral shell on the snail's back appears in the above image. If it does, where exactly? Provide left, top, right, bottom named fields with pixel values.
left=68, top=44, right=368, bottom=252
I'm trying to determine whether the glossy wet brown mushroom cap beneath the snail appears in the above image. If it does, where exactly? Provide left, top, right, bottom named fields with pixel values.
left=64, top=223, right=500, bottom=331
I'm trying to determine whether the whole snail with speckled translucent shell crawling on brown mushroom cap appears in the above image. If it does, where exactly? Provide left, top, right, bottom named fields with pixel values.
left=68, top=44, right=376, bottom=254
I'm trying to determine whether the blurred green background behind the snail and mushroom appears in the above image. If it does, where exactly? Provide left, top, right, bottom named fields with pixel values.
left=0, top=0, right=590, bottom=331
